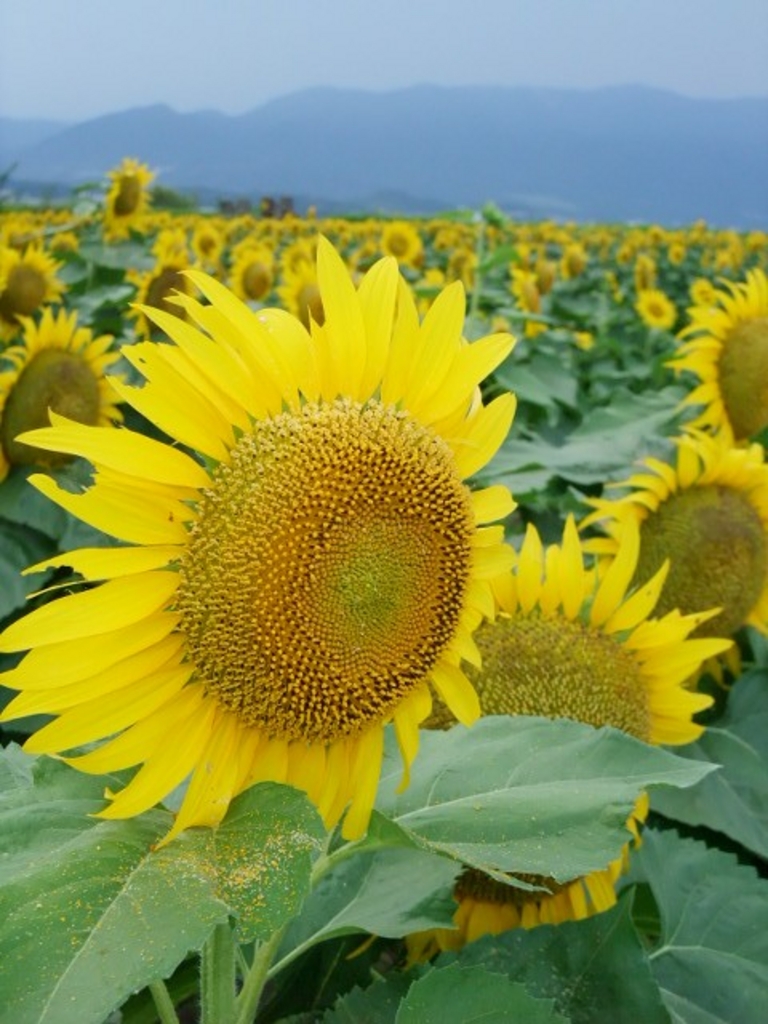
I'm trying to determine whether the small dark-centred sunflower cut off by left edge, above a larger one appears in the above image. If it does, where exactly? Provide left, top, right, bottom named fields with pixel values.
left=0, top=244, right=65, bottom=339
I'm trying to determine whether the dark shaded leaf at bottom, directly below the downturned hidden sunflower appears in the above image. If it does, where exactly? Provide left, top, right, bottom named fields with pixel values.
left=437, top=898, right=669, bottom=1024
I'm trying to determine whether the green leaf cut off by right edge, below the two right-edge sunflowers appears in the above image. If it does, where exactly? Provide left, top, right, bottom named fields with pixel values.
left=653, top=669, right=768, bottom=857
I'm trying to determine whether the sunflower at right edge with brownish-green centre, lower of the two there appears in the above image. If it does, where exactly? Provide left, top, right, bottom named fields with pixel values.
left=584, top=430, right=768, bottom=637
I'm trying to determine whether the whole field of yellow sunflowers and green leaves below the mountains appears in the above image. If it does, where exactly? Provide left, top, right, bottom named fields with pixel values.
left=0, top=159, right=768, bottom=1024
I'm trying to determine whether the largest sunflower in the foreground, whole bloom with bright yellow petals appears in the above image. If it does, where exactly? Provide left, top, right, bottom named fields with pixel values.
left=0, top=241, right=514, bottom=839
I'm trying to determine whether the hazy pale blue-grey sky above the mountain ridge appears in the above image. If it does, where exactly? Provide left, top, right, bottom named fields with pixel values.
left=0, top=0, right=768, bottom=121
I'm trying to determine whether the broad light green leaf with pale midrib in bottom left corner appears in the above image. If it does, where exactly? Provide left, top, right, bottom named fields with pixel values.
left=0, top=764, right=228, bottom=1024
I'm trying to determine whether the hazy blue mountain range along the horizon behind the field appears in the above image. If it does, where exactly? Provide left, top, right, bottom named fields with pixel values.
left=0, top=85, right=768, bottom=228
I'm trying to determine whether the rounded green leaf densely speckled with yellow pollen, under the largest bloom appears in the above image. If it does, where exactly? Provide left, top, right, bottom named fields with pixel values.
left=177, top=782, right=326, bottom=942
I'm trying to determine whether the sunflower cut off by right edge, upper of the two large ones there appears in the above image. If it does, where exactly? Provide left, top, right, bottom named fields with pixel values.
left=670, top=269, right=768, bottom=441
